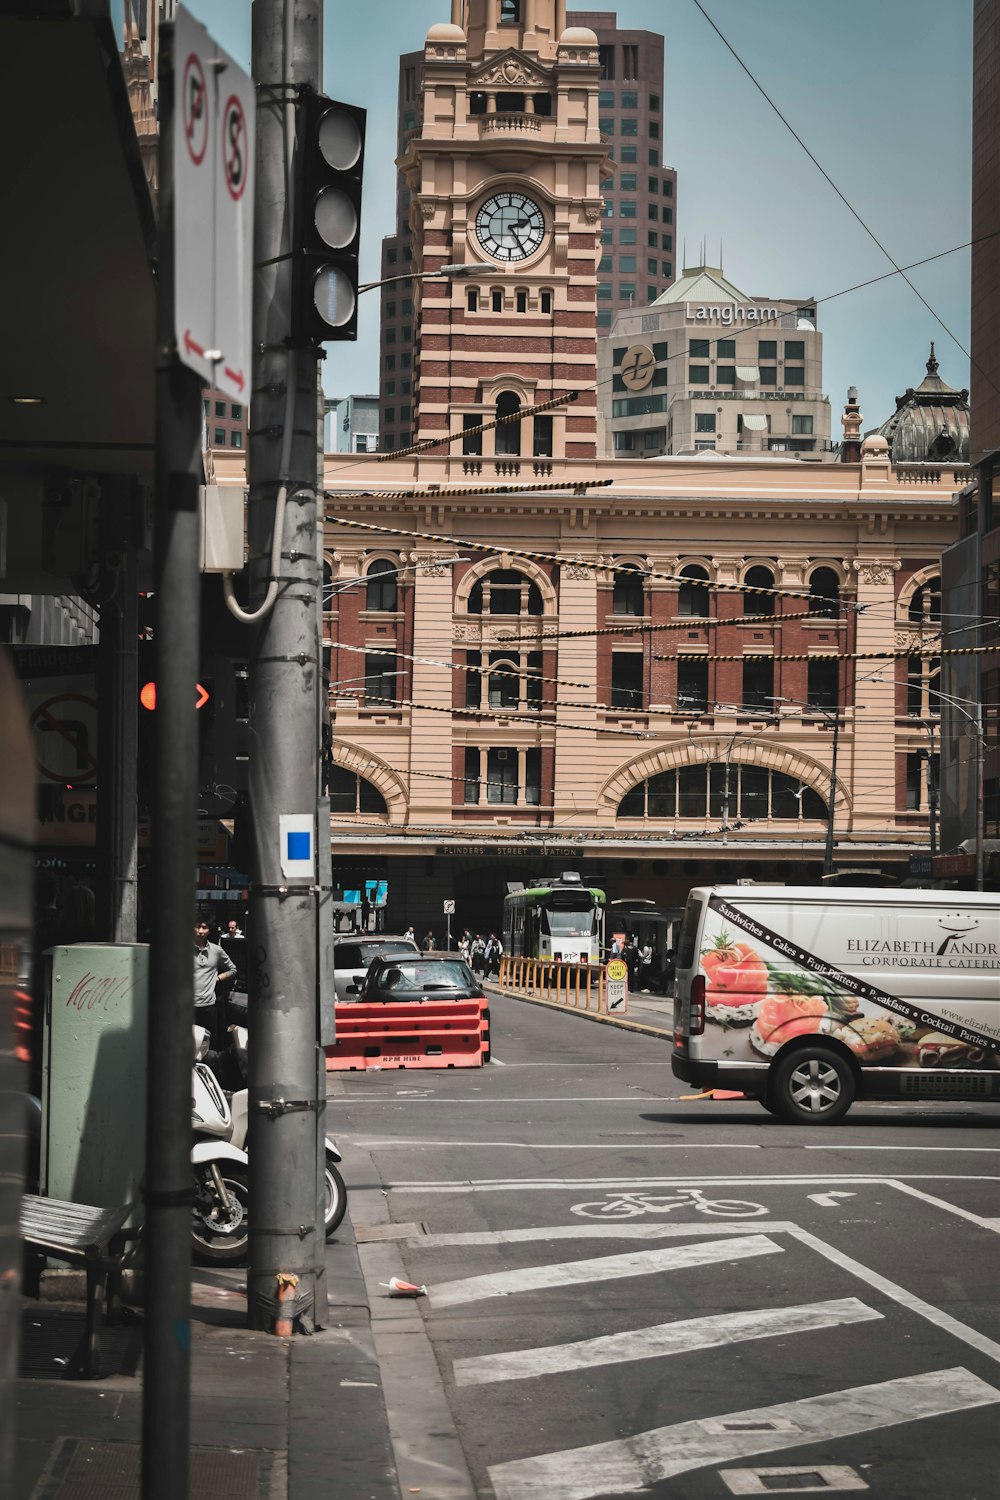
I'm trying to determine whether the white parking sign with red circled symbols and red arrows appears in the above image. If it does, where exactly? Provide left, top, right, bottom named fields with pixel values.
left=172, top=6, right=256, bottom=402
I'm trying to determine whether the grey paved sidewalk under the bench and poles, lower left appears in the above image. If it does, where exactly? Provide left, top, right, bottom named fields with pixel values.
left=14, top=1214, right=400, bottom=1500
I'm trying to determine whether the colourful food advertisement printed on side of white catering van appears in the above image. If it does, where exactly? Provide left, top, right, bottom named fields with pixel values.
left=699, top=894, right=1000, bottom=1070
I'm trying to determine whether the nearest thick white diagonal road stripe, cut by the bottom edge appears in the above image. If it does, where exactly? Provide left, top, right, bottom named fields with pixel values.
left=489, top=1367, right=1000, bottom=1500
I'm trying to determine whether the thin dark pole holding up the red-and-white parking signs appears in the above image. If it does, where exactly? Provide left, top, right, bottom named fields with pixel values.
left=142, top=17, right=201, bottom=1500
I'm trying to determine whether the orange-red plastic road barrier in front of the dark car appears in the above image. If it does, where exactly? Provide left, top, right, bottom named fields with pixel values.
left=324, top=1001, right=490, bottom=1073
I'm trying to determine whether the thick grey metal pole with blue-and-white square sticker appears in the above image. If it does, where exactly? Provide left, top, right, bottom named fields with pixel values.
left=247, top=0, right=322, bottom=1332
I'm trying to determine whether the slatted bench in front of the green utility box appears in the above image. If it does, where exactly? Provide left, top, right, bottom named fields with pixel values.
left=21, top=1193, right=139, bottom=1380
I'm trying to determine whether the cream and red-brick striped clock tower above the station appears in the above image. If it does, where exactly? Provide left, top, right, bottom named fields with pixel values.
left=399, top=0, right=609, bottom=459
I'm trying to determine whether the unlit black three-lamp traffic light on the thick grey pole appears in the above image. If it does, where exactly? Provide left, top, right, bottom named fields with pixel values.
left=292, top=93, right=366, bottom=347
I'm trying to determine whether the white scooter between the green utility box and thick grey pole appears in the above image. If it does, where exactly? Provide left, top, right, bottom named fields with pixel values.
left=190, top=1026, right=250, bottom=1266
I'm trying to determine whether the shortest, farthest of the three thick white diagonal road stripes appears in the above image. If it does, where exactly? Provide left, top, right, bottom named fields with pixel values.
left=430, top=1235, right=783, bottom=1308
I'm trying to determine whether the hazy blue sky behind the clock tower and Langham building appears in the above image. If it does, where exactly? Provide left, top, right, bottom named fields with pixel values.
left=177, top=0, right=972, bottom=438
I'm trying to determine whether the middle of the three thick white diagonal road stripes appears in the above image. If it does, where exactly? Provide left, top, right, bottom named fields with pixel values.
left=454, top=1298, right=883, bottom=1386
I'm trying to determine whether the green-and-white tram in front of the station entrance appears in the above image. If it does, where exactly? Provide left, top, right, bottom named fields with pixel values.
left=504, top=870, right=607, bottom=963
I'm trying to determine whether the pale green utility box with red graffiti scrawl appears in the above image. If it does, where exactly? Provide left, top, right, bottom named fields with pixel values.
left=40, top=944, right=148, bottom=1208
